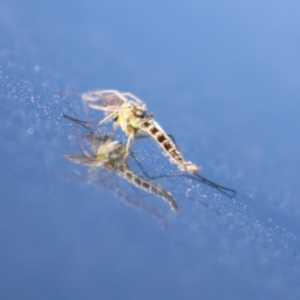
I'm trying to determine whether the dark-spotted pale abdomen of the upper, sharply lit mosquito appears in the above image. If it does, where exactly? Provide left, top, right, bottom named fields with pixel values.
left=140, top=119, right=199, bottom=173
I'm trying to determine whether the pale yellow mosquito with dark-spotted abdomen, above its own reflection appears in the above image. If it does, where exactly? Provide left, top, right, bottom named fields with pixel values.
left=67, top=90, right=200, bottom=173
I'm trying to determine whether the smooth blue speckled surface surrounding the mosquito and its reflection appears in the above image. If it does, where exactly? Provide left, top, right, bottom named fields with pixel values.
left=0, top=0, right=300, bottom=299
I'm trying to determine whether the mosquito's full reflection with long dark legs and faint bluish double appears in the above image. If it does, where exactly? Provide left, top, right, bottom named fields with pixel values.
left=63, top=111, right=236, bottom=216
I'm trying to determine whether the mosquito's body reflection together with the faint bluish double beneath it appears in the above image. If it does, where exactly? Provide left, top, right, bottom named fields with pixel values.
left=63, top=116, right=178, bottom=227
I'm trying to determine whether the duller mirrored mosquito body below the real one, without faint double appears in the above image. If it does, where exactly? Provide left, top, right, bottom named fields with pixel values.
left=63, top=116, right=178, bottom=211
